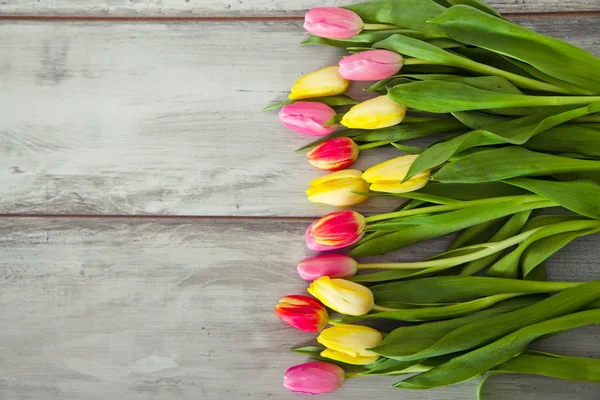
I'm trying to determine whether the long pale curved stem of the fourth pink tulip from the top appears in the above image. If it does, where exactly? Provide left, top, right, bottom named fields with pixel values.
left=358, top=227, right=543, bottom=269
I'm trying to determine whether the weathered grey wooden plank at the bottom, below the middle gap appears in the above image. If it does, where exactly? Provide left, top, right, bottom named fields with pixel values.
left=0, top=218, right=600, bottom=400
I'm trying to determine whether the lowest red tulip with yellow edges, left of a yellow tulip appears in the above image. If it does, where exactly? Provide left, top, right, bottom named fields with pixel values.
left=275, top=295, right=329, bottom=332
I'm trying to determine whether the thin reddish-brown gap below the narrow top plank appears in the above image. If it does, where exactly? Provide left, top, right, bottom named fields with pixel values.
left=0, top=11, right=600, bottom=23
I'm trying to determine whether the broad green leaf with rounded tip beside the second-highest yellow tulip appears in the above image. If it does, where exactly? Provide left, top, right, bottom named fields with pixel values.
left=388, top=80, right=600, bottom=113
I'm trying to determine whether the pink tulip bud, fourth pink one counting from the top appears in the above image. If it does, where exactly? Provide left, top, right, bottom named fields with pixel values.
left=297, top=254, right=358, bottom=282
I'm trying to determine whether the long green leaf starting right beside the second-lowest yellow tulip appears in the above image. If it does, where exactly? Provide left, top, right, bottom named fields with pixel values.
left=371, top=276, right=579, bottom=306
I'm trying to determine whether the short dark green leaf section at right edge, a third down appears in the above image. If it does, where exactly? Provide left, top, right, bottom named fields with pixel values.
left=528, top=121, right=600, bottom=156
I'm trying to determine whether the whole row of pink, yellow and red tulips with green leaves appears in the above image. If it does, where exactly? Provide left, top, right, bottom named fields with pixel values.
left=266, top=0, right=600, bottom=393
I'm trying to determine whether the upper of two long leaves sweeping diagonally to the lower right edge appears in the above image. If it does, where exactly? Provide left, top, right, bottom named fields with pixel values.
left=386, top=281, right=600, bottom=361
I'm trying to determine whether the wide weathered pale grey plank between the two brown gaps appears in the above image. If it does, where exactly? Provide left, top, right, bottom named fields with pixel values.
left=0, top=17, right=600, bottom=216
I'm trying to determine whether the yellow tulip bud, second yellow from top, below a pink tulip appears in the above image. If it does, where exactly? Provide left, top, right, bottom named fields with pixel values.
left=342, top=95, right=406, bottom=129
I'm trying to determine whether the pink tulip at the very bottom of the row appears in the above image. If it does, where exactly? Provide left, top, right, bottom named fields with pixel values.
left=283, top=361, right=345, bottom=394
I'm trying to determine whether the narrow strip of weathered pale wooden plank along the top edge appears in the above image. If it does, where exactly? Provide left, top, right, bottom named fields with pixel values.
left=0, top=0, right=600, bottom=17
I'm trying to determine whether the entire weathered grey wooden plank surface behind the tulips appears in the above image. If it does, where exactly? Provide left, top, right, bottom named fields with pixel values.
left=0, top=0, right=600, bottom=400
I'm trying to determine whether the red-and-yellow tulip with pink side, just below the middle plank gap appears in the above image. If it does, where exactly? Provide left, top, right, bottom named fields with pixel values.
left=304, top=210, right=365, bottom=251
